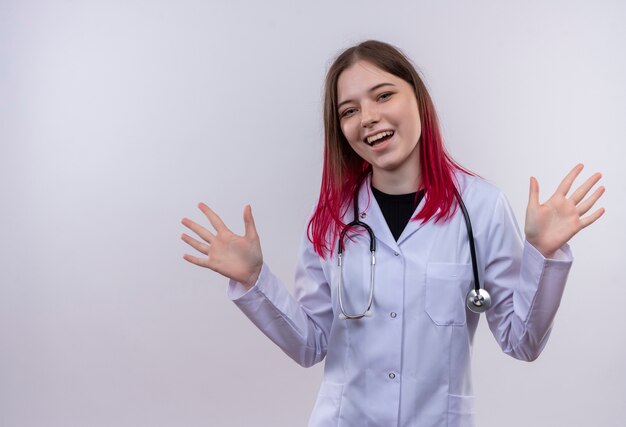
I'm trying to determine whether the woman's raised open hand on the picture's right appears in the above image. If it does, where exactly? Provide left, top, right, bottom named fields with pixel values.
left=524, top=164, right=604, bottom=258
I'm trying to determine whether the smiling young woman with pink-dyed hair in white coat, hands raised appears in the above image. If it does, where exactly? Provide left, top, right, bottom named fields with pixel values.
left=182, top=41, right=604, bottom=427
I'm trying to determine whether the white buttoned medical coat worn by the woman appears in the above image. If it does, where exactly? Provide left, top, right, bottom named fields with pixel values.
left=229, top=174, right=572, bottom=427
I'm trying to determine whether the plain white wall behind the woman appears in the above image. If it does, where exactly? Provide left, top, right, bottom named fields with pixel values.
left=0, top=0, right=626, bottom=427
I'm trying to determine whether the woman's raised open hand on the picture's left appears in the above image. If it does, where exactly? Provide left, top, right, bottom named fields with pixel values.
left=181, top=203, right=263, bottom=289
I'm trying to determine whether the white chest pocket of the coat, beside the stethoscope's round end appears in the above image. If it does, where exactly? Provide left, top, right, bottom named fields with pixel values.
left=425, top=262, right=472, bottom=326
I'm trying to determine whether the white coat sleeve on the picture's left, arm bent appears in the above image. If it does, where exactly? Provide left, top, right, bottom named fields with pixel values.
left=228, top=236, right=333, bottom=367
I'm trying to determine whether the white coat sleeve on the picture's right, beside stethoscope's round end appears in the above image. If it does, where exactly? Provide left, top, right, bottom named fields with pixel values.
left=483, top=194, right=572, bottom=361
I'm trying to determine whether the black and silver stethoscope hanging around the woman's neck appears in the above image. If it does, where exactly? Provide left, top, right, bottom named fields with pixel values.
left=337, top=187, right=491, bottom=319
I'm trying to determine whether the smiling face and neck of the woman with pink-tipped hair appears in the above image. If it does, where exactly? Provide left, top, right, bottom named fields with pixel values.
left=337, top=60, right=422, bottom=193
